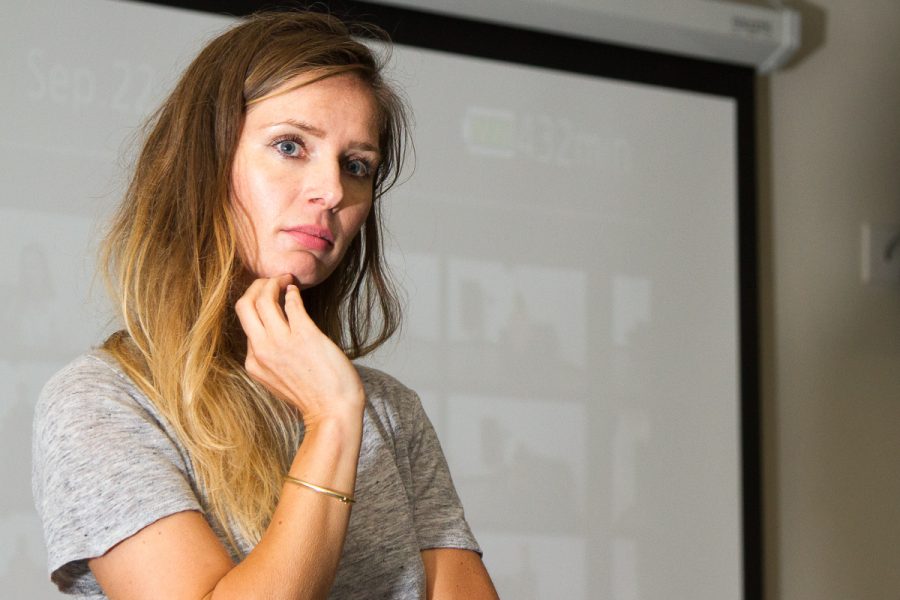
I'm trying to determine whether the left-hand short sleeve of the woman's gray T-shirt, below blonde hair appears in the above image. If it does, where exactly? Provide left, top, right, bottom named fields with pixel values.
left=32, top=355, right=200, bottom=594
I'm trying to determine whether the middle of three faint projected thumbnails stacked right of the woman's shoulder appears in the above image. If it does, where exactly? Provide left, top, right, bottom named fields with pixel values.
left=444, top=394, right=588, bottom=535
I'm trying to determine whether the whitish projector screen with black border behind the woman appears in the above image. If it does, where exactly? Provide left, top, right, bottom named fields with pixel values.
left=0, top=0, right=746, bottom=600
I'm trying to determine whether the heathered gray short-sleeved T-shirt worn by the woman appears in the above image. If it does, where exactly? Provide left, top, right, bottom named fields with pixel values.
left=33, top=351, right=480, bottom=599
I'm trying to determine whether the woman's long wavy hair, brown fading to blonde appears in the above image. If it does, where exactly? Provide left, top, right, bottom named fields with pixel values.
left=100, top=12, right=408, bottom=552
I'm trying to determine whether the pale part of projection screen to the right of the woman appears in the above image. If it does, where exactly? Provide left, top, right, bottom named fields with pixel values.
left=383, top=43, right=741, bottom=600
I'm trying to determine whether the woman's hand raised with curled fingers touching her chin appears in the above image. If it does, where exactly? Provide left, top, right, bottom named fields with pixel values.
left=235, top=274, right=365, bottom=428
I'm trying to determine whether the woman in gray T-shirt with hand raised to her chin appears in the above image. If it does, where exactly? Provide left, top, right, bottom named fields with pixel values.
left=34, top=13, right=496, bottom=599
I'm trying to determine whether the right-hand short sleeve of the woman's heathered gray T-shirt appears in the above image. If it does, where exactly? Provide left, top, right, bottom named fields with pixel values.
left=403, top=392, right=481, bottom=555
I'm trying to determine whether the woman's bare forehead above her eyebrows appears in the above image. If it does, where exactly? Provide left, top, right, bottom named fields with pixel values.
left=246, top=71, right=379, bottom=139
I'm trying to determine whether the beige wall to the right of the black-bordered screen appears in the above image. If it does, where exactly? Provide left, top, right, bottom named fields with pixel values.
left=759, top=0, right=900, bottom=600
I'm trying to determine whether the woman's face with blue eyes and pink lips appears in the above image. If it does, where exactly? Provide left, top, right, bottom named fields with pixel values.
left=231, top=73, right=381, bottom=288
